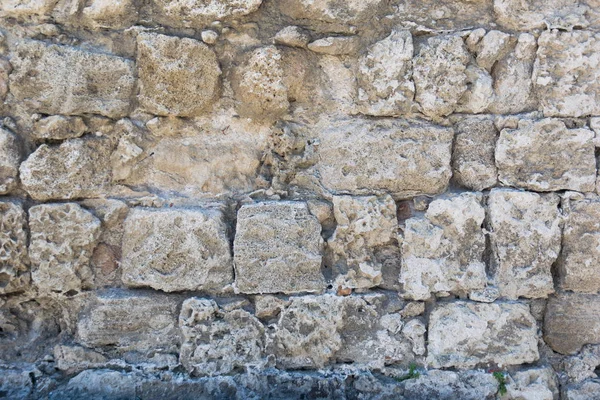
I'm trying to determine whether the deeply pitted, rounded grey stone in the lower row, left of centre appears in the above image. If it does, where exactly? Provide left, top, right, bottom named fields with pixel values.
left=179, top=298, right=265, bottom=376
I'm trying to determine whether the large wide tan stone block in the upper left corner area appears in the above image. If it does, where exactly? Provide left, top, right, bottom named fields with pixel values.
left=10, top=41, right=134, bottom=118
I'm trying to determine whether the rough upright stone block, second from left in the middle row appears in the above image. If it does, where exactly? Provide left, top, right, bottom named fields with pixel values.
left=29, top=203, right=100, bottom=293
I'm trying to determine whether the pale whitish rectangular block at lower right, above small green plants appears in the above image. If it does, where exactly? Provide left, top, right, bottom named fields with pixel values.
left=427, top=301, right=539, bottom=368
